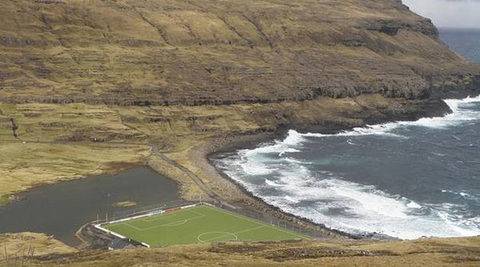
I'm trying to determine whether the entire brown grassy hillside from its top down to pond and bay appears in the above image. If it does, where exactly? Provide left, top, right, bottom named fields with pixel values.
left=0, top=0, right=480, bottom=203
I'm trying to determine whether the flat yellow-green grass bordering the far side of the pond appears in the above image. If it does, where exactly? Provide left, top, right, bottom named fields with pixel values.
left=0, top=142, right=148, bottom=203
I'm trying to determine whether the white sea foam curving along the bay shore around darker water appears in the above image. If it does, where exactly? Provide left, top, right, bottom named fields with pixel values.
left=216, top=96, right=480, bottom=239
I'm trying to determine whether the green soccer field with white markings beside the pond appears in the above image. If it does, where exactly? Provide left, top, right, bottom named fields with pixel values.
left=102, top=205, right=308, bottom=247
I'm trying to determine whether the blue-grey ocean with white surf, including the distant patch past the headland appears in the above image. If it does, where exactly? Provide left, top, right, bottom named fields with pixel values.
left=213, top=29, right=480, bottom=239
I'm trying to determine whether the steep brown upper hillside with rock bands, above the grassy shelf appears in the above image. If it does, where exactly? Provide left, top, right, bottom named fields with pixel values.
left=0, top=0, right=480, bottom=105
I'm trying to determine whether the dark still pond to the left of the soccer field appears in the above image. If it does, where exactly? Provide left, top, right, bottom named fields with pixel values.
left=0, top=167, right=179, bottom=245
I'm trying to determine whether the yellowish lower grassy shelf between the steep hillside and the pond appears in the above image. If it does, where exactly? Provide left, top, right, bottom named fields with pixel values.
left=0, top=96, right=432, bottom=203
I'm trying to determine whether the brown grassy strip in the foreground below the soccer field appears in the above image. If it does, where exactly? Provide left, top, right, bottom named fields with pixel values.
left=4, top=237, right=480, bottom=267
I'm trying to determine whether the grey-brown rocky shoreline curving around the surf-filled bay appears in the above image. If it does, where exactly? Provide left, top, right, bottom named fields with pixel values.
left=75, top=91, right=480, bottom=245
